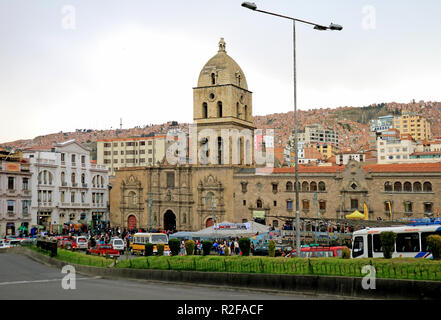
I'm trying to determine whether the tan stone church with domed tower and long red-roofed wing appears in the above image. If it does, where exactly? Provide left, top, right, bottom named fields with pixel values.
left=110, top=39, right=441, bottom=231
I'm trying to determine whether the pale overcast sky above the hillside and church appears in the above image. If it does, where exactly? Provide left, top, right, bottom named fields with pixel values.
left=0, top=0, right=441, bottom=142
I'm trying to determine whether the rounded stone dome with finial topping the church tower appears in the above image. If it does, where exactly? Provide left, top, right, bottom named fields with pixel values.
left=198, top=38, right=248, bottom=90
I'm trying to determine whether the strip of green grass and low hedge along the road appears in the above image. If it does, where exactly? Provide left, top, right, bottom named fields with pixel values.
left=24, top=247, right=441, bottom=281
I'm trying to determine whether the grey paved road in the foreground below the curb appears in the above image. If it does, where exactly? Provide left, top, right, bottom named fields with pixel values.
left=0, top=253, right=344, bottom=300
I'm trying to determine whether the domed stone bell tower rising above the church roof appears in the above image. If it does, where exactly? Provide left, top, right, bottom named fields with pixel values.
left=193, top=38, right=255, bottom=166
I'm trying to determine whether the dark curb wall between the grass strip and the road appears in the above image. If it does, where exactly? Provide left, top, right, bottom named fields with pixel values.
left=3, top=247, right=441, bottom=300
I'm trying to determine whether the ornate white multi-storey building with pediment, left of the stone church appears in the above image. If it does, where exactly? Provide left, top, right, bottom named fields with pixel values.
left=23, top=140, right=109, bottom=232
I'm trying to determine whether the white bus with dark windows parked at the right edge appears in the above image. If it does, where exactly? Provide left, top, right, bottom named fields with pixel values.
left=351, top=224, right=441, bottom=258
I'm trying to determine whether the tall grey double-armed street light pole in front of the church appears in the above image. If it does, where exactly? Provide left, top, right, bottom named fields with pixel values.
left=242, top=2, right=343, bottom=256
